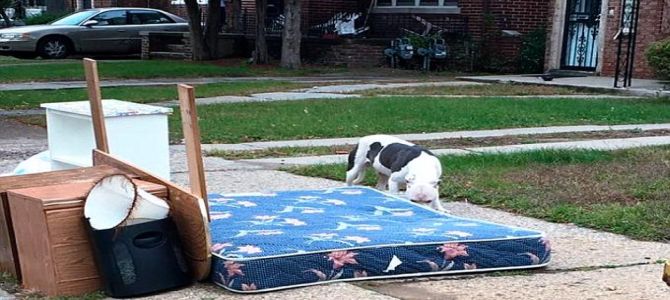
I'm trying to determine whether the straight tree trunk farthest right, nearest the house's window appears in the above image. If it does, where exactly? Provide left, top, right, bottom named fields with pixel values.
left=280, top=0, right=302, bottom=69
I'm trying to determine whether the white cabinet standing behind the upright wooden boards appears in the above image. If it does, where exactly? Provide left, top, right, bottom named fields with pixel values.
left=41, top=100, right=172, bottom=179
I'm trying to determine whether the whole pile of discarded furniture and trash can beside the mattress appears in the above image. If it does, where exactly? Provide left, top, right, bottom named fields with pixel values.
left=0, top=60, right=211, bottom=297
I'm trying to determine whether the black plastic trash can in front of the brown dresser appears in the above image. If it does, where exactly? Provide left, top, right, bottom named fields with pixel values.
left=85, top=218, right=192, bottom=298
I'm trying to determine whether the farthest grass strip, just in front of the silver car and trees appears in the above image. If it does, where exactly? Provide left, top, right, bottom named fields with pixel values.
left=0, top=60, right=342, bottom=83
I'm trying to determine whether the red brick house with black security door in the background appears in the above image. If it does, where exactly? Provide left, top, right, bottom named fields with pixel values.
left=52, top=0, right=670, bottom=78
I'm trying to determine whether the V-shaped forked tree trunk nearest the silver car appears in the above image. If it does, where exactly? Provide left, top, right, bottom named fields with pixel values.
left=184, top=0, right=221, bottom=60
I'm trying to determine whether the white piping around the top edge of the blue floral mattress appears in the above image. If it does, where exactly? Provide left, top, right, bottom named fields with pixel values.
left=212, top=186, right=546, bottom=262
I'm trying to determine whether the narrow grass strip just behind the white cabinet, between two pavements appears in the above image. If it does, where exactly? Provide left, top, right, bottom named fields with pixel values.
left=0, top=80, right=309, bottom=109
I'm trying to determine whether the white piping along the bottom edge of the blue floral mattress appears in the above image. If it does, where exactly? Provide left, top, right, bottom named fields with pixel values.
left=213, top=262, right=549, bottom=294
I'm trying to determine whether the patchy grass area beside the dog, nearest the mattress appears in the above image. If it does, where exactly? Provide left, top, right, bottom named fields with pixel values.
left=288, top=147, right=670, bottom=242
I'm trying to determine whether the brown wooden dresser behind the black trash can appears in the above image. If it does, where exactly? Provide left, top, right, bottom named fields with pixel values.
left=7, top=179, right=167, bottom=296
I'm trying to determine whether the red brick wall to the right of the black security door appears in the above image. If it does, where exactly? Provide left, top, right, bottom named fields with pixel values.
left=601, top=0, right=670, bottom=78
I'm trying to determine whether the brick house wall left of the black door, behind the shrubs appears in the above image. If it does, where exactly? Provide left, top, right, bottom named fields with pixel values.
left=86, top=0, right=551, bottom=72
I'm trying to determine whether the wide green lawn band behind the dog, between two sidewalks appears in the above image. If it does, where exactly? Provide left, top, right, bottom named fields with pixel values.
left=170, top=97, right=670, bottom=143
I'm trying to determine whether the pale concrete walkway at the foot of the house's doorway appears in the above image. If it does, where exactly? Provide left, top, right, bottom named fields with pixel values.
left=459, top=75, right=670, bottom=97
